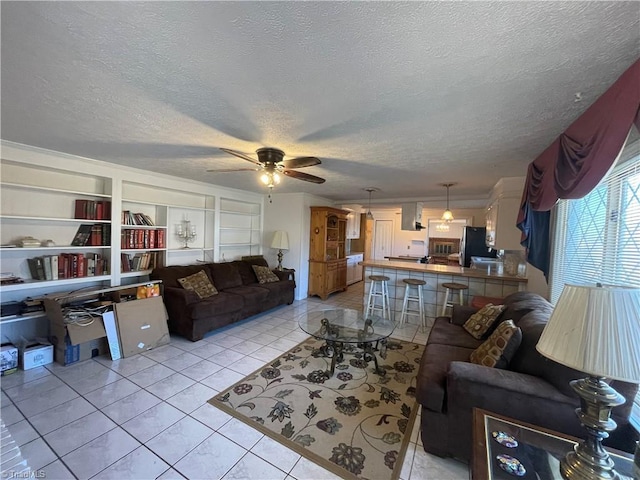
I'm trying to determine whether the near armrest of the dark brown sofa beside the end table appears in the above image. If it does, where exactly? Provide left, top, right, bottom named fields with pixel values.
left=447, top=362, right=579, bottom=406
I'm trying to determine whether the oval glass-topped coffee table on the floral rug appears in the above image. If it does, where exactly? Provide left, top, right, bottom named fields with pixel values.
left=298, top=308, right=395, bottom=378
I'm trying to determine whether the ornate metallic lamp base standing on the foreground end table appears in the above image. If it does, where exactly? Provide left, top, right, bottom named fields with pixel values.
left=560, top=377, right=625, bottom=480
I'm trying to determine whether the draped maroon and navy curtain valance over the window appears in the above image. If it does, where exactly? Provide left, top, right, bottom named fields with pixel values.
left=517, top=60, right=640, bottom=276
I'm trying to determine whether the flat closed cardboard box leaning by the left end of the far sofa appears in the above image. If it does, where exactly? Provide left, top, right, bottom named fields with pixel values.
left=114, top=297, right=170, bottom=357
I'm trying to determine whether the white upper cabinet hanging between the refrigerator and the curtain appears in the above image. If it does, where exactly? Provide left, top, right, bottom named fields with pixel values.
left=486, top=177, right=524, bottom=250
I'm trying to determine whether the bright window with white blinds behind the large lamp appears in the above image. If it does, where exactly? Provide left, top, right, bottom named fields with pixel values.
left=550, top=135, right=640, bottom=429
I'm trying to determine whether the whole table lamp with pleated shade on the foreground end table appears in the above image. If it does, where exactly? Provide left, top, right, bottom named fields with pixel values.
left=536, top=285, right=640, bottom=479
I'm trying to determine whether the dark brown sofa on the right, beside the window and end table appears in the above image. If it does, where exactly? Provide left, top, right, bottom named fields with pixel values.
left=416, top=292, right=638, bottom=461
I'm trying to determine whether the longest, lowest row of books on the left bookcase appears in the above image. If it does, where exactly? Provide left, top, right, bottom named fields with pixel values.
left=27, top=253, right=109, bottom=280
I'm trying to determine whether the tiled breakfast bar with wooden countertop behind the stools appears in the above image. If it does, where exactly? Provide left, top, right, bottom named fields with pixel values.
left=361, top=260, right=527, bottom=325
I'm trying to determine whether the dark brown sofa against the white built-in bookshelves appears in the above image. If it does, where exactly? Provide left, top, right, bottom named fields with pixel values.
left=150, top=258, right=296, bottom=342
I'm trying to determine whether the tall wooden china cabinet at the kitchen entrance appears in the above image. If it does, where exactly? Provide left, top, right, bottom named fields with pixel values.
left=308, top=207, right=349, bottom=300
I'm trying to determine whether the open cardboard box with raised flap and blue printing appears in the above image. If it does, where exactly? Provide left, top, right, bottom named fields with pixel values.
left=44, top=298, right=107, bottom=365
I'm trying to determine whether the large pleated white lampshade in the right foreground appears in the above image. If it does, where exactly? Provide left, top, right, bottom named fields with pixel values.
left=536, top=285, right=640, bottom=383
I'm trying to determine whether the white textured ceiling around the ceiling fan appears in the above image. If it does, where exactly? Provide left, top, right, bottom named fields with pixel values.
left=1, top=1, right=640, bottom=201
